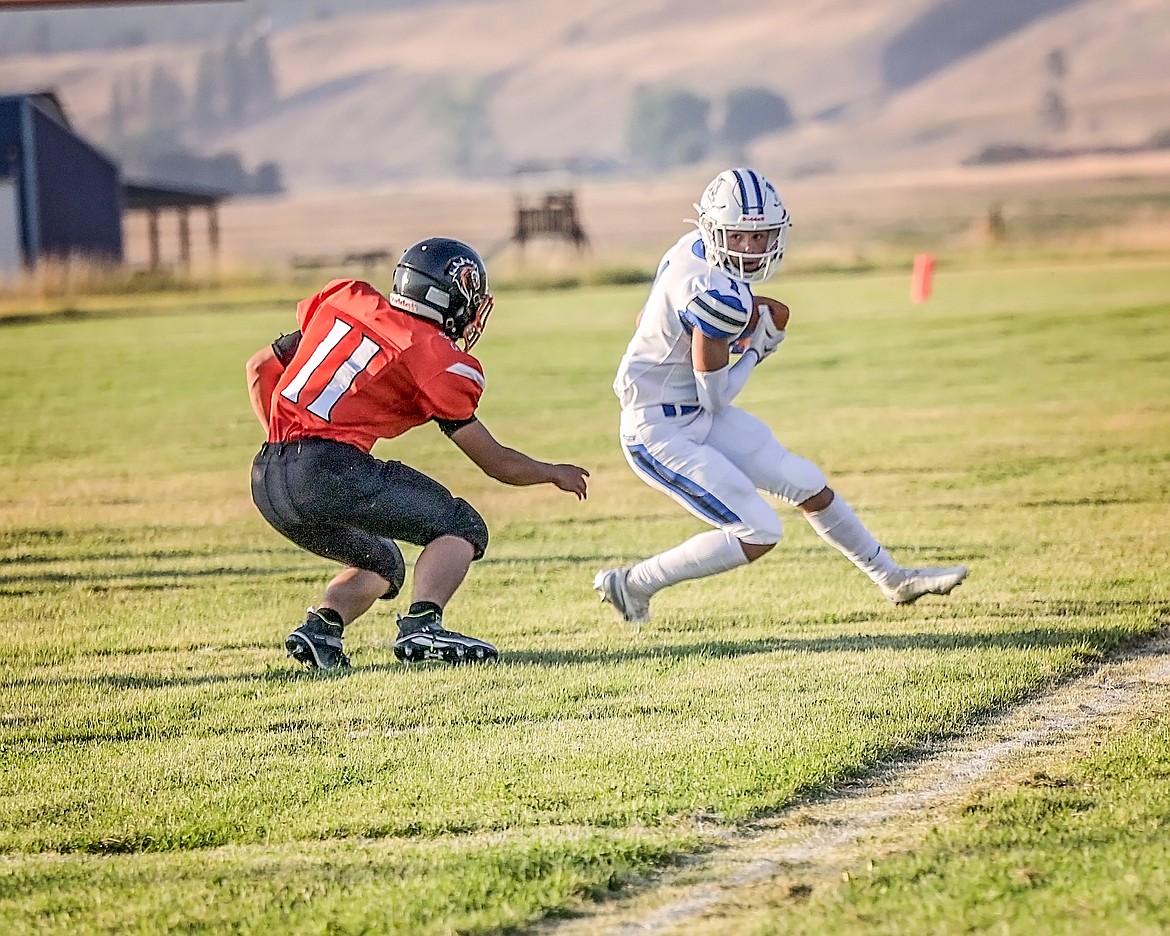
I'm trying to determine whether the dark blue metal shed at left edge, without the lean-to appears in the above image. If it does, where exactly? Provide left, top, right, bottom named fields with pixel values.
left=0, top=91, right=123, bottom=274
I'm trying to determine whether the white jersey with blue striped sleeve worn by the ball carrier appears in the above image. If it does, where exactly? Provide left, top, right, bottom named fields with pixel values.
left=613, top=230, right=752, bottom=411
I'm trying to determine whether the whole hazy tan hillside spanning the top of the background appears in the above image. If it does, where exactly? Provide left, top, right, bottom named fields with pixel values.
left=0, top=0, right=1170, bottom=192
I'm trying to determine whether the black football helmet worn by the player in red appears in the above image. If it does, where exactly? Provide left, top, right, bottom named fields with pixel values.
left=390, top=238, right=493, bottom=351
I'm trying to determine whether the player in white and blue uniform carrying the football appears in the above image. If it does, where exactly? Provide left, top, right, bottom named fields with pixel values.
left=593, top=168, right=966, bottom=622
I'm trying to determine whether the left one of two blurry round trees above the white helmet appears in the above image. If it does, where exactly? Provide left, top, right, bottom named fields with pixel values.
left=627, top=84, right=711, bottom=168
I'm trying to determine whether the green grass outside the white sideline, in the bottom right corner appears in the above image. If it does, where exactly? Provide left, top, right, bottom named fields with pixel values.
left=707, top=704, right=1170, bottom=936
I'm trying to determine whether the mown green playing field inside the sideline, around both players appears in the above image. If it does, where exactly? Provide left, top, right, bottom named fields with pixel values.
left=0, top=262, right=1170, bottom=934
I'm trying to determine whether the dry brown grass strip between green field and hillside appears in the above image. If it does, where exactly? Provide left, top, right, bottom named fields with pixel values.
left=126, top=152, right=1170, bottom=275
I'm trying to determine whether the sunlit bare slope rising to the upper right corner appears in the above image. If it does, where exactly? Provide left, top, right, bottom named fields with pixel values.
left=755, top=0, right=1170, bottom=172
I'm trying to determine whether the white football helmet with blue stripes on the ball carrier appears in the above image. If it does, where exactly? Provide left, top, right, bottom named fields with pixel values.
left=694, top=168, right=791, bottom=283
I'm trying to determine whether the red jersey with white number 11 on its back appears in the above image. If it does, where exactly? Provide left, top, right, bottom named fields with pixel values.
left=268, top=280, right=484, bottom=452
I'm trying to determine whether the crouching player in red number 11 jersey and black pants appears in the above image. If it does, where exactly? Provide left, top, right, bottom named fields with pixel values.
left=247, top=238, right=589, bottom=669
